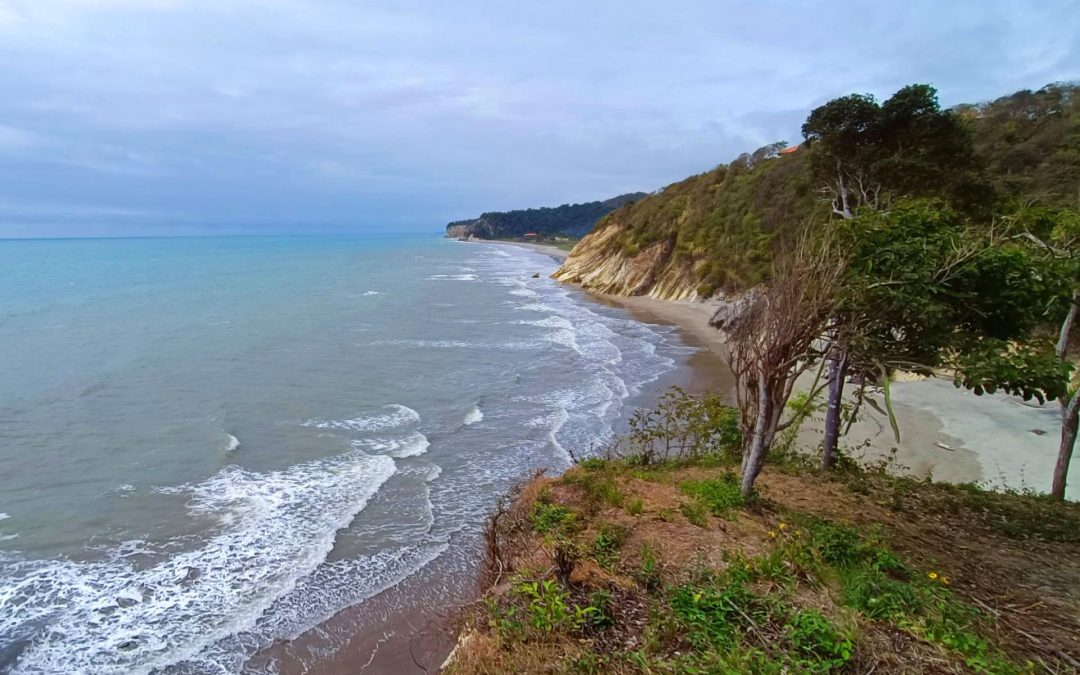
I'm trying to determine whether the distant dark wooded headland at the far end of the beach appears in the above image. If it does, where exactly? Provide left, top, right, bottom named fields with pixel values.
left=446, top=192, right=646, bottom=239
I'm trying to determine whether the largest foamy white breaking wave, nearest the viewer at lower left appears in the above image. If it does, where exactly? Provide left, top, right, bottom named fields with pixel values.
left=0, top=450, right=395, bottom=674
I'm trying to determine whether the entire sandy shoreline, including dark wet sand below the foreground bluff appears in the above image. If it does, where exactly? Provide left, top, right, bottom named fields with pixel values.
left=317, top=240, right=1076, bottom=675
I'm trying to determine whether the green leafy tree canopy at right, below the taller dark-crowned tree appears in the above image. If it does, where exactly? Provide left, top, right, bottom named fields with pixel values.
left=823, top=200, right=1080, bottom=494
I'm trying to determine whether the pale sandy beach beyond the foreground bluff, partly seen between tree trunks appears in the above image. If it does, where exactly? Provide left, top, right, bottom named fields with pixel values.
left=488, top=242, right=1080, bottom=500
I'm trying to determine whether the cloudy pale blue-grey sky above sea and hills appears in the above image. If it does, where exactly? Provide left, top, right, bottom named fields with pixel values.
left=0, top=0, right=1080, bottom=238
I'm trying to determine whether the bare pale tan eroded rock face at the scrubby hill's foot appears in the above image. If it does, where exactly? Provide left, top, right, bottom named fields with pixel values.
left=552, top=224, right=700, bottom=300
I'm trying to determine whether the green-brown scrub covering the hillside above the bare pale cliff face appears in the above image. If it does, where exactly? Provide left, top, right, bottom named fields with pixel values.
left=571, top=84, right=1080, bottom=296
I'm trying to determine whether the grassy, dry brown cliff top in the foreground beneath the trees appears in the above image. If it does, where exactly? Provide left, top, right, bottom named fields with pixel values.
left=448, top=386, right=1080, bottom=674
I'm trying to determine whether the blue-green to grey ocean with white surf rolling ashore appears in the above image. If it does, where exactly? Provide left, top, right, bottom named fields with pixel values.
left=0, top=235, right=693, bottom=674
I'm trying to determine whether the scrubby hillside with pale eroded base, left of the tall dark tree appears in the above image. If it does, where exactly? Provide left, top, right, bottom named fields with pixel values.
left=554, top=146, right=815, bottom=300
